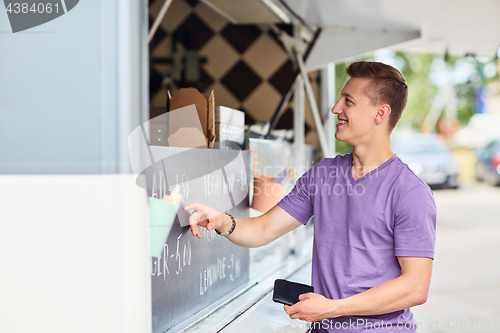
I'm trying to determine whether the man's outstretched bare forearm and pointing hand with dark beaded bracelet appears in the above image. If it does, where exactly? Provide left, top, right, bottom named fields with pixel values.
left=185, top=203, right=302, bottom=247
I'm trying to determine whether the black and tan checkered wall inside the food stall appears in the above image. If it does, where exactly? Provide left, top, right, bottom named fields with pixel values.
left=149, top=0, right=318, bottom=137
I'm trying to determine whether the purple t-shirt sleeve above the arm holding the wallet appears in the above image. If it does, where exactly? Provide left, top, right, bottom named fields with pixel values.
left=394, top=183, right=436, bottom=259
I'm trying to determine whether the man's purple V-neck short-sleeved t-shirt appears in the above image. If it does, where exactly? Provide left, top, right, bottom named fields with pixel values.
left=278, top=154, right=436, bottom=333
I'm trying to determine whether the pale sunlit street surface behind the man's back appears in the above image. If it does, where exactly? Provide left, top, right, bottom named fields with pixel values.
left=413, top=182, right=500, bottom=333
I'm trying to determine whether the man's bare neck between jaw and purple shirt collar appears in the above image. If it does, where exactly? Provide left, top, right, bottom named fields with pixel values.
left=352, top=137, right=394, bottom=180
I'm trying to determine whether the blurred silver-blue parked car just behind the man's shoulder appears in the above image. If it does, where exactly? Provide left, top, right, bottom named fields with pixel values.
left=392, top=134, right=458, bottom=188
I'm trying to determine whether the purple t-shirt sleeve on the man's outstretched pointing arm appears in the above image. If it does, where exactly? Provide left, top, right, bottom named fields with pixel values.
left=278, top=162, right=321, bottom=224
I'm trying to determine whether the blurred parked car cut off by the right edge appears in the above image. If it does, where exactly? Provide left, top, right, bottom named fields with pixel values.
left=476, top=139, right=500, bottom=186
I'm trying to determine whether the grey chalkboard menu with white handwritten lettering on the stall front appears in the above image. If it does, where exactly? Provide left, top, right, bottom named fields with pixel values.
left=138, top=146, right=251, bottom=333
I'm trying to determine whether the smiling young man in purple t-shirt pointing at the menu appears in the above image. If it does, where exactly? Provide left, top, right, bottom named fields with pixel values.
left=186, top=62, right=436, bottom=332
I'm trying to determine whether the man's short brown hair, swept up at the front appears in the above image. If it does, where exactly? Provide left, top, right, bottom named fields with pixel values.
left=346, top=61, right=408, bottom=131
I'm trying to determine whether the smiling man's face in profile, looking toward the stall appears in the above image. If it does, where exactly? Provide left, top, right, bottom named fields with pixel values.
left=332, top=78, right=378, bottom=145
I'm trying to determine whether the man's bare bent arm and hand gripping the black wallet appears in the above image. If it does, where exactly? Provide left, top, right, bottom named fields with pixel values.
left=285, top=257, right=433, bottom=321
